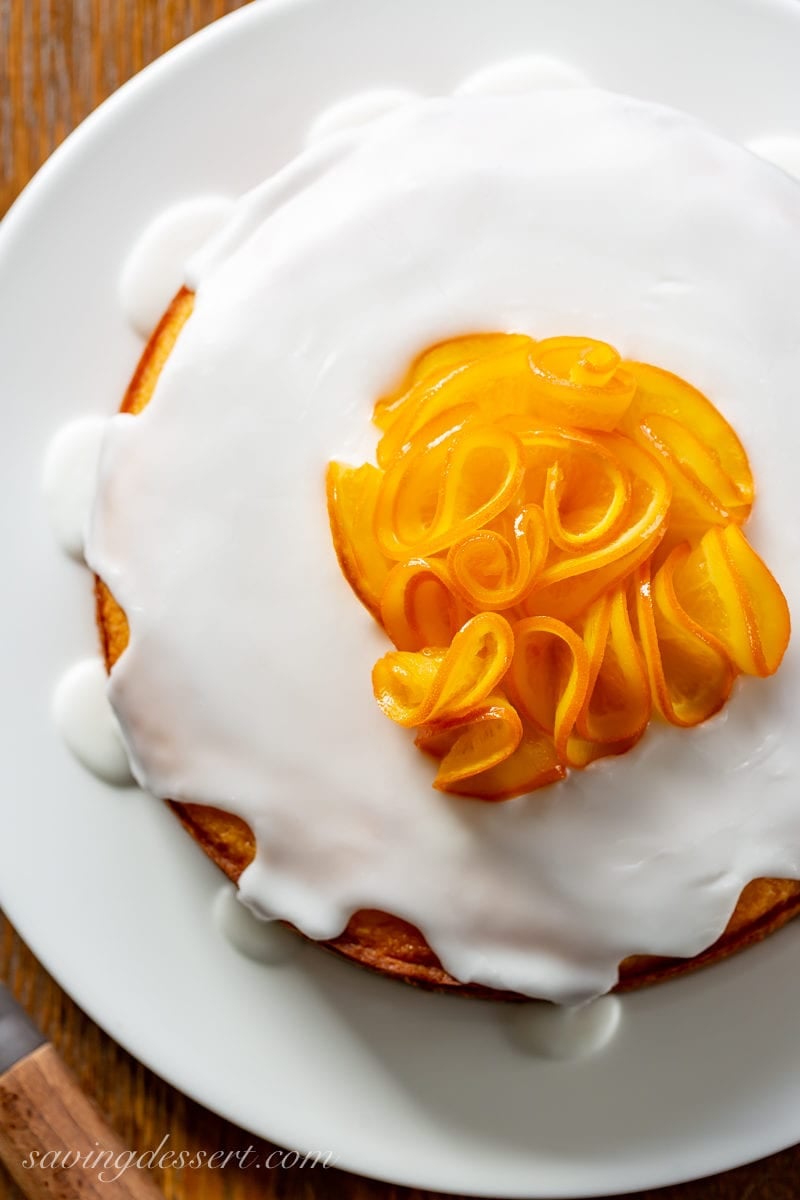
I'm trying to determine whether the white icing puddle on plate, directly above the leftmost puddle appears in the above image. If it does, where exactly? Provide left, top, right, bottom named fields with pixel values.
left=120, top=196, right=234, bottom=337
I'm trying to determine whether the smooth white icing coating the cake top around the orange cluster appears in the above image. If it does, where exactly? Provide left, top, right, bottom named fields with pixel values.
left=82, top=90, right=800, bottom=1003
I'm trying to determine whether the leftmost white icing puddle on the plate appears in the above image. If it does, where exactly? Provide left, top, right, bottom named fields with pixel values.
left=42, top=416, right=108, bottom=559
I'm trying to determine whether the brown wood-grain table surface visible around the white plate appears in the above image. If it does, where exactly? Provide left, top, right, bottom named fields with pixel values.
left=0, top=0, right=800, bottom=1200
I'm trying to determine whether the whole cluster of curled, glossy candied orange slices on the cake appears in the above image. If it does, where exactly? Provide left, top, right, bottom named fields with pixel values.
left=327, top=334, right=790, bottom=800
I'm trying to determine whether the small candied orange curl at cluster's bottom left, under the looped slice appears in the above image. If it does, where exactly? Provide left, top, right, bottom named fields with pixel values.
left=415, top=694, right=522, bottom=792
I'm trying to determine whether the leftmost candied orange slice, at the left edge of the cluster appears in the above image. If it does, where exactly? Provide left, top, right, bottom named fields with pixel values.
left=326, top=453, right=392, bottom=617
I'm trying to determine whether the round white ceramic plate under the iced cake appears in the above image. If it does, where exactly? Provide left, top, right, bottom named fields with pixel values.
left=0, top=0, right=800, bottom=1196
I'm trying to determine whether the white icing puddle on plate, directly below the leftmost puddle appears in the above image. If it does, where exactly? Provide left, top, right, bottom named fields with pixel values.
left=53, top=658, right=133, bottom=787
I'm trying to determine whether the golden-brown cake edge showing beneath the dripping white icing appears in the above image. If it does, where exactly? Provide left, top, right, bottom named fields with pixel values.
left=96, top=288, right=800, bottom=1000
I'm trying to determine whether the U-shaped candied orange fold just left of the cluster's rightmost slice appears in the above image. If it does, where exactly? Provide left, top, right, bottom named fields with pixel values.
left=636, top=545, right=735, bottom=727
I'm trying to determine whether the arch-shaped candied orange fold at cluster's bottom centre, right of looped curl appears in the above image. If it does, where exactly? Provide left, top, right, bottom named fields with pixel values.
left=507, top=617, right=589, bottom=762
